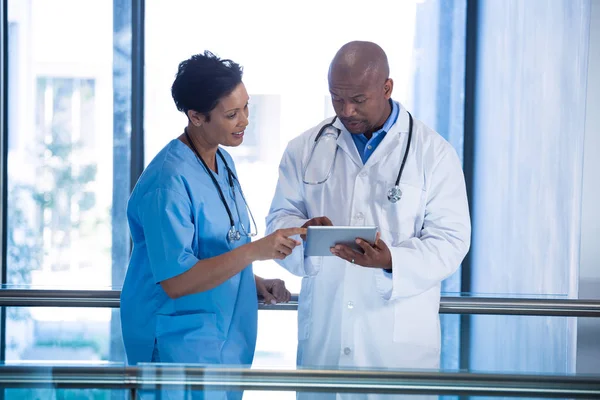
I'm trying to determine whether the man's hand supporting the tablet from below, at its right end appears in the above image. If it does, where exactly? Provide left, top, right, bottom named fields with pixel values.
left=331, top=232, right=392, bottom=269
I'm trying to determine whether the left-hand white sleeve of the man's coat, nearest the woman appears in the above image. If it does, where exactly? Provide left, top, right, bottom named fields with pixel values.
left=265, top=141, right=316, bottom=276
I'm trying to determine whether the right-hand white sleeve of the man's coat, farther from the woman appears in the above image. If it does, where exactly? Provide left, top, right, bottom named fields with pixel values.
left=376, top=149, right=471, bottom=300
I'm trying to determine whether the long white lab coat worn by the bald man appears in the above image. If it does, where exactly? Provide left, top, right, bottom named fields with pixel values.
left=267, top=101, right=471, bottom=399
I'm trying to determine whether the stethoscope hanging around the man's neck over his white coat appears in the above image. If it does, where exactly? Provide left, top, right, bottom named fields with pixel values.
left=302, top=111, right=413, bottom=203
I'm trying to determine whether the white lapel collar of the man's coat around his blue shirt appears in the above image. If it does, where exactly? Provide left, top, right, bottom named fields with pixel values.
left=333, top=102, right=414, bottom=168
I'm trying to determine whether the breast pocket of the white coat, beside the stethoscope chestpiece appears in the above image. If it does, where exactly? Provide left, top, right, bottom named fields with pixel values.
left=375, top=181, right=426, bottom=246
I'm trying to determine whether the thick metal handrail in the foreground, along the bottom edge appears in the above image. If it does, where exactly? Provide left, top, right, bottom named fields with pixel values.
left=0, top=365, right=600, bottom=399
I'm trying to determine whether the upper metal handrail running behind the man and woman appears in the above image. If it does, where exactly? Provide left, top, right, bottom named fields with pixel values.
left=0, top=289, right=600, bottom=317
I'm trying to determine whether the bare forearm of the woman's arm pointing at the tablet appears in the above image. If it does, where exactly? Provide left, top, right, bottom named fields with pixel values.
left=160, top=242, right=257, bottom=299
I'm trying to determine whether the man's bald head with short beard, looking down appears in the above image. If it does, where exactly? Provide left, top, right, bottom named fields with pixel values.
left=329, top=42, right=394, bottom=138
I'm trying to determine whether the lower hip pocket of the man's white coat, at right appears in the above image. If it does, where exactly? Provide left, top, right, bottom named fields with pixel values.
left=394, top=288, right=441, bottom=351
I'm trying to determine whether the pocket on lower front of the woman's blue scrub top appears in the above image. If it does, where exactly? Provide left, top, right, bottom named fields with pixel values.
left=156, top=313, right=225, bottom=364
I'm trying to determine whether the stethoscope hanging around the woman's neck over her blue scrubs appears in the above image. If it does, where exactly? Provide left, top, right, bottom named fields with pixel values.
left=184, top=129, right=258, bottom=242
